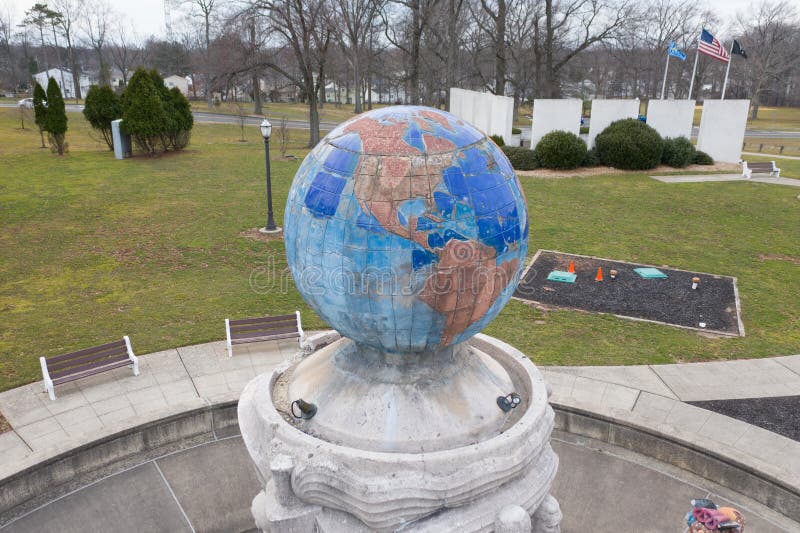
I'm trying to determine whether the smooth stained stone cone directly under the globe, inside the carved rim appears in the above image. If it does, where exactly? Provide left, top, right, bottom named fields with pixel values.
left=282, top=339, right=516, bottom=453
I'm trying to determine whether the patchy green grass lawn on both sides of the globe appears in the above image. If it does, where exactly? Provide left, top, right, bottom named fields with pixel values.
left=0, top=109, right=800, bottom=390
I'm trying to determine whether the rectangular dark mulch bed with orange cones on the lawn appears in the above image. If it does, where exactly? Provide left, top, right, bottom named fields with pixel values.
left=514, top=251, right=740, bottom=335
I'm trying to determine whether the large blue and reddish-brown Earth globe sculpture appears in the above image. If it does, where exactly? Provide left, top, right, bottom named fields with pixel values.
left=284, top=106, right=528, bottom=353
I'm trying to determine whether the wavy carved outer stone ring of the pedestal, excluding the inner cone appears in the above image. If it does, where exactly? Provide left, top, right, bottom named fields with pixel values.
left=239, top=335, right=561, bottom=533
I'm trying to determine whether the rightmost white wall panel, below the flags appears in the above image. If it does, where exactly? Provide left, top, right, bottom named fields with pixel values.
left=697, top=100, right=750, bottom=163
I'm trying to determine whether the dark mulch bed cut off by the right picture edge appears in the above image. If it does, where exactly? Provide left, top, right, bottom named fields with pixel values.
left=689, top=396, right=800, bottom=442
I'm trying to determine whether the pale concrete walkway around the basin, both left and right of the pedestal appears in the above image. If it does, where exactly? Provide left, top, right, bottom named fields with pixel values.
left=0, top=340, right=800, bottom=516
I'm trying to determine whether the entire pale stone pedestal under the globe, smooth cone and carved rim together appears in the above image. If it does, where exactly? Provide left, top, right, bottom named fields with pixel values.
left=239, top=335, right=561, bottom=533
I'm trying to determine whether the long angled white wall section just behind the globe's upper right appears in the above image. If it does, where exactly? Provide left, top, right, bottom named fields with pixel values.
left=450, top=87, right=514, bottom=142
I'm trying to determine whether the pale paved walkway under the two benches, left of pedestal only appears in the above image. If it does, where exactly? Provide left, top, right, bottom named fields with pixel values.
left=0, top=339, right=298, bottom=479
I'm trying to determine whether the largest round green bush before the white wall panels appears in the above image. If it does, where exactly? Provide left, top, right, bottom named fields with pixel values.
left=594, top=118, right=664, bottom=170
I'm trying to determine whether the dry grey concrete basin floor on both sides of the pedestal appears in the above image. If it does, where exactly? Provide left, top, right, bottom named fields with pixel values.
left=0, top=435, right=792, bottom=533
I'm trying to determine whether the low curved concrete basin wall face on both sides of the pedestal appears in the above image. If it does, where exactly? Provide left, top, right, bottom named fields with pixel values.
left=0, top=401, right=800, bottom=526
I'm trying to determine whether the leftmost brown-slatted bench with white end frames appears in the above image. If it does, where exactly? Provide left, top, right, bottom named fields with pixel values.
left=39, top=335, right=139, bottom=400
